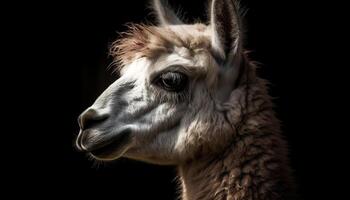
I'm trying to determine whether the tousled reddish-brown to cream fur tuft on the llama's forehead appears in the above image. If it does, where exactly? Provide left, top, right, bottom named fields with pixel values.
left=110, top=24, right=211, bottom=70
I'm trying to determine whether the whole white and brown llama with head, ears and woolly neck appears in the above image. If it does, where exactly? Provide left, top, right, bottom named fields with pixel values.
left=76, top=0, right=293, bottom=200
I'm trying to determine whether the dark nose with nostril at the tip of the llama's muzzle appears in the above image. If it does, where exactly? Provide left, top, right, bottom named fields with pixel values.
left=78, top=108, right=109, bottom=130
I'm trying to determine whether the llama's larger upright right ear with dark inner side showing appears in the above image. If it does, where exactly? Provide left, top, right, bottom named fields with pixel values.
left=210, top=0, right=242, bottom=60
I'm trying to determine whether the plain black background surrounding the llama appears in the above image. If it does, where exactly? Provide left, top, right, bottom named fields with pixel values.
left=6, top=0, right=343, bottom=199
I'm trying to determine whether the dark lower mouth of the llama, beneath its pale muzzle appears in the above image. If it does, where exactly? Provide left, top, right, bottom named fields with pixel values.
left=89, top=130, right=131, bottom=160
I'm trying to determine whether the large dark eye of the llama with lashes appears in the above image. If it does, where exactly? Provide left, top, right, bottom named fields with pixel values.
left=156, top=72, right=188, bottom=92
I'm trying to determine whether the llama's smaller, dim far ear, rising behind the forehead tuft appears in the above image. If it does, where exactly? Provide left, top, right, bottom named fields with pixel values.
left=152, top=0, right=183, bottom=26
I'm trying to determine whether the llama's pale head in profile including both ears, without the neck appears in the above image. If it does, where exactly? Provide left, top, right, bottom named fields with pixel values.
left=76, top=0, right=246, bottom=164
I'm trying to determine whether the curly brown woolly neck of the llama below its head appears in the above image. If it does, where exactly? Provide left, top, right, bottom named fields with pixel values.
left=179, top=61, right=292, bottom=200
